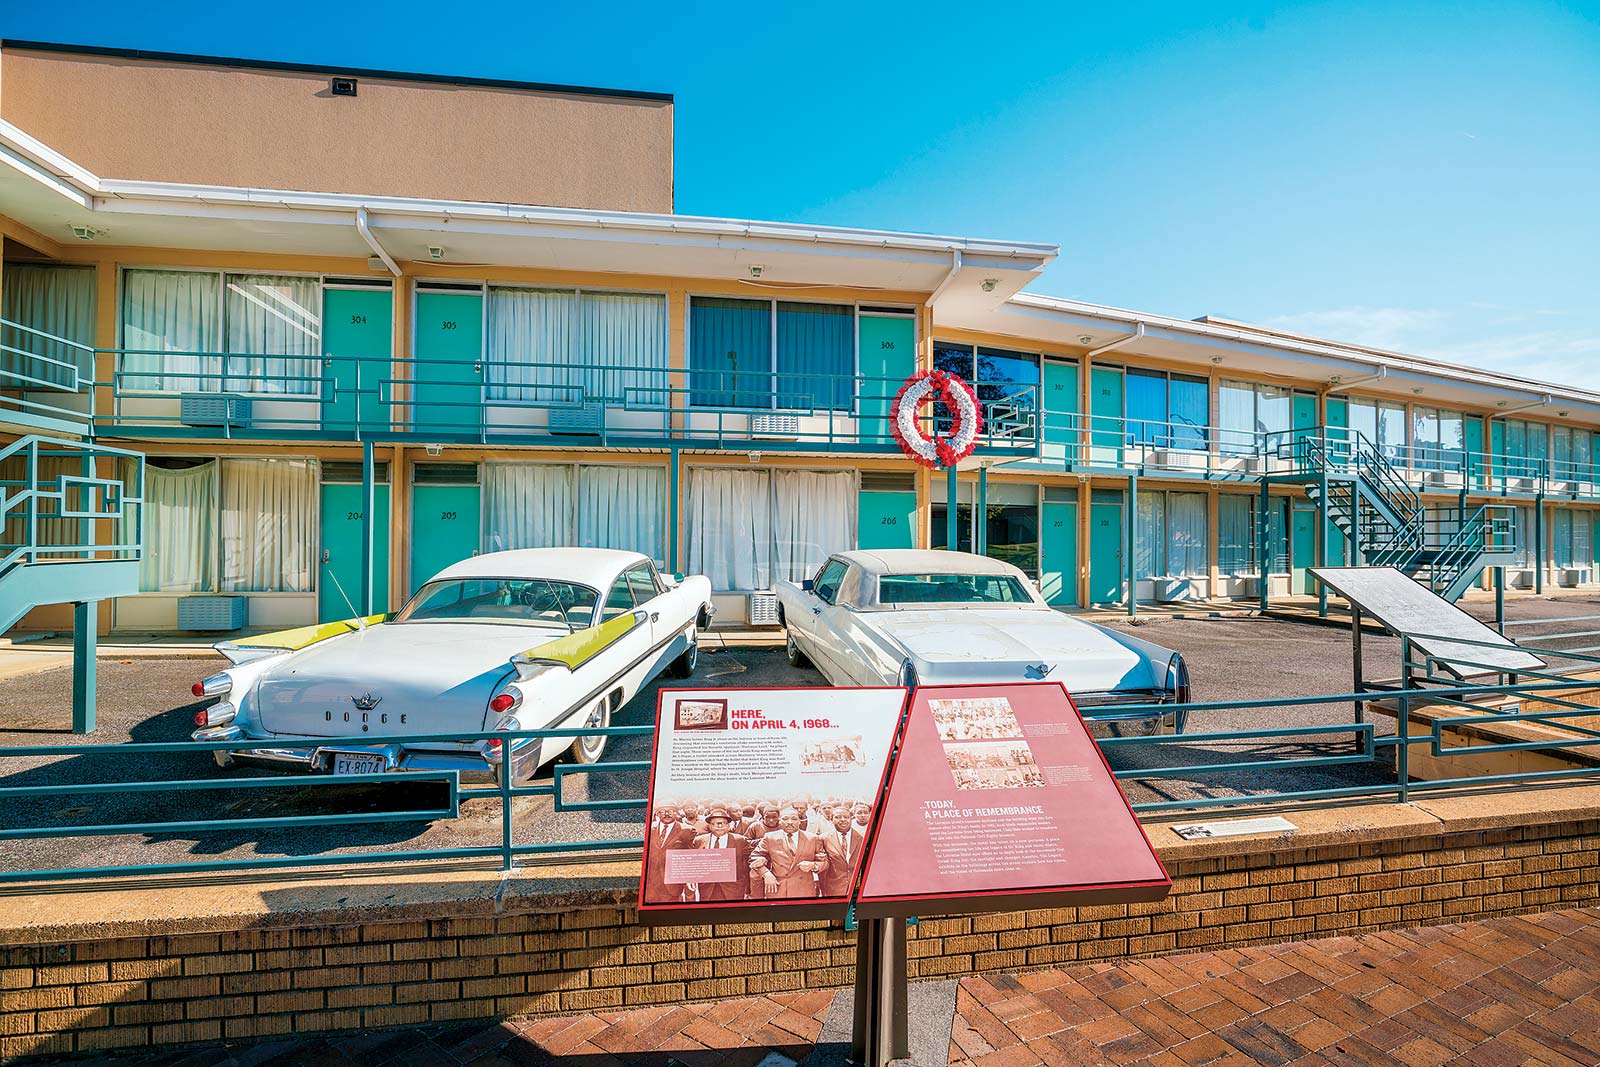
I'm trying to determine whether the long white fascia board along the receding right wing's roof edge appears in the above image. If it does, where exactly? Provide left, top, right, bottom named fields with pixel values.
left=1011, top=293, right=1600, bottom=405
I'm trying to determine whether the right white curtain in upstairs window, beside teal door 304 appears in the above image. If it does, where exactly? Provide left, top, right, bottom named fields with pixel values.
left=227, top=274, right=322, bottom=397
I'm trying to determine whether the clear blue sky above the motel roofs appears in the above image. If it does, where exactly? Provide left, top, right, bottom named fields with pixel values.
left=0, top=0, right=1600, bottom=389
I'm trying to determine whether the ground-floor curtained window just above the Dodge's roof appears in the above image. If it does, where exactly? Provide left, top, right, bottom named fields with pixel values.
left=482, top=462, right=667, bottom=566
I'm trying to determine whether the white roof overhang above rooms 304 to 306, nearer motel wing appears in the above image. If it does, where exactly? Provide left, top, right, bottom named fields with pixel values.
left=0, top=122, right=1059, bottom=300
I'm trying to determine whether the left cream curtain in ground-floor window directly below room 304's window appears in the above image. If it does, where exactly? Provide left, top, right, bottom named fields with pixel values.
left=139, top=461, right=216, bottom=593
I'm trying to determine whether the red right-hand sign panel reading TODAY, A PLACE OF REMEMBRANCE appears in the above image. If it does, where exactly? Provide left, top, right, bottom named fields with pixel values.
left=856, top=683, right=1171, bottom=918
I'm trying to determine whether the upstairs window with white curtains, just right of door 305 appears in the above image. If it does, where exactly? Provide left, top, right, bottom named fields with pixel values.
left=483, top=285, right=669, bottom=408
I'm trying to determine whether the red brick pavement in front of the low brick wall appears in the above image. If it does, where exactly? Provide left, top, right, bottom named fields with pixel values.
left=21, top=909, right=1600, bottom=1067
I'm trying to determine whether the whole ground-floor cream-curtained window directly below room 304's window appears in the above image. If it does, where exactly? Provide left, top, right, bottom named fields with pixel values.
left=139, top=456, right=318, bottom=593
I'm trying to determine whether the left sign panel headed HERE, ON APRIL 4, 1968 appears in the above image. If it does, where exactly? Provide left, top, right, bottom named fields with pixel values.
left=638, top=688, right=907, bottom=923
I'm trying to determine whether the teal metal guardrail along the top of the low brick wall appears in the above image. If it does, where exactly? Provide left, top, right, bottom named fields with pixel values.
left=0, top=659, right=1600, bottom=883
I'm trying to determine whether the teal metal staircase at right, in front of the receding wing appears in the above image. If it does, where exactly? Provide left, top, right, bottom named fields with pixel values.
left=1278, top=427, right=1517, bottom=601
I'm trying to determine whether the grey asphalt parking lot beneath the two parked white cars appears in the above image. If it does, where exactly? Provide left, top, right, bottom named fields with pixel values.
left=0, top=601, right=1574, bottom=870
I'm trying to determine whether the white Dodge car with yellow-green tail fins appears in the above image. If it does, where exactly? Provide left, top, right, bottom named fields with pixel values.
left=194, top=549, right=712, bottom=781
